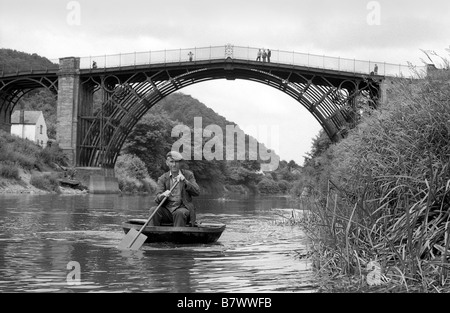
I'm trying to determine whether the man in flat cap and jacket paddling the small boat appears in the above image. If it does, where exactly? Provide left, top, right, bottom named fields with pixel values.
left=149, top=151, right=200, bottom=227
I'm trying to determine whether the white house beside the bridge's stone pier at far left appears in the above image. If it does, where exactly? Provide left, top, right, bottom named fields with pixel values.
left=11, top=110, right=48, bottom=148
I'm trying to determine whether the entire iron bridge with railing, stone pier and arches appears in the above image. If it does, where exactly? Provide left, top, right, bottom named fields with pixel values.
left=0, top=44, right=420, bottom=168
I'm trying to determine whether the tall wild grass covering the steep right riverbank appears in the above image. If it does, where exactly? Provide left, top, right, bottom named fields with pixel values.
left=302, top=70, right=450, bottom=291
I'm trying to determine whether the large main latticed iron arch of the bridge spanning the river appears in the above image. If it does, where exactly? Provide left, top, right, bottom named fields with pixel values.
left=76, top=58, right=379, bottom=168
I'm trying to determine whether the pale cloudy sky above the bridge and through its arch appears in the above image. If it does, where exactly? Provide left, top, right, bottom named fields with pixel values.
left=0, top=0, right=450, bottom=165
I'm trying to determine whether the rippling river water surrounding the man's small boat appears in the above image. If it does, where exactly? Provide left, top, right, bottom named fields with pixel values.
left=0, top=194, right=314, bottom=293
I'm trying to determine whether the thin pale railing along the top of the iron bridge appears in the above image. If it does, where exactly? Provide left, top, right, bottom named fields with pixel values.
left=80, top=45, right=426, bottom=77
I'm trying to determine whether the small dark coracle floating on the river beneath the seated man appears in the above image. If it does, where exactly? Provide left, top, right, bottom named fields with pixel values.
left=122, top=218, right=226, bottom=243
